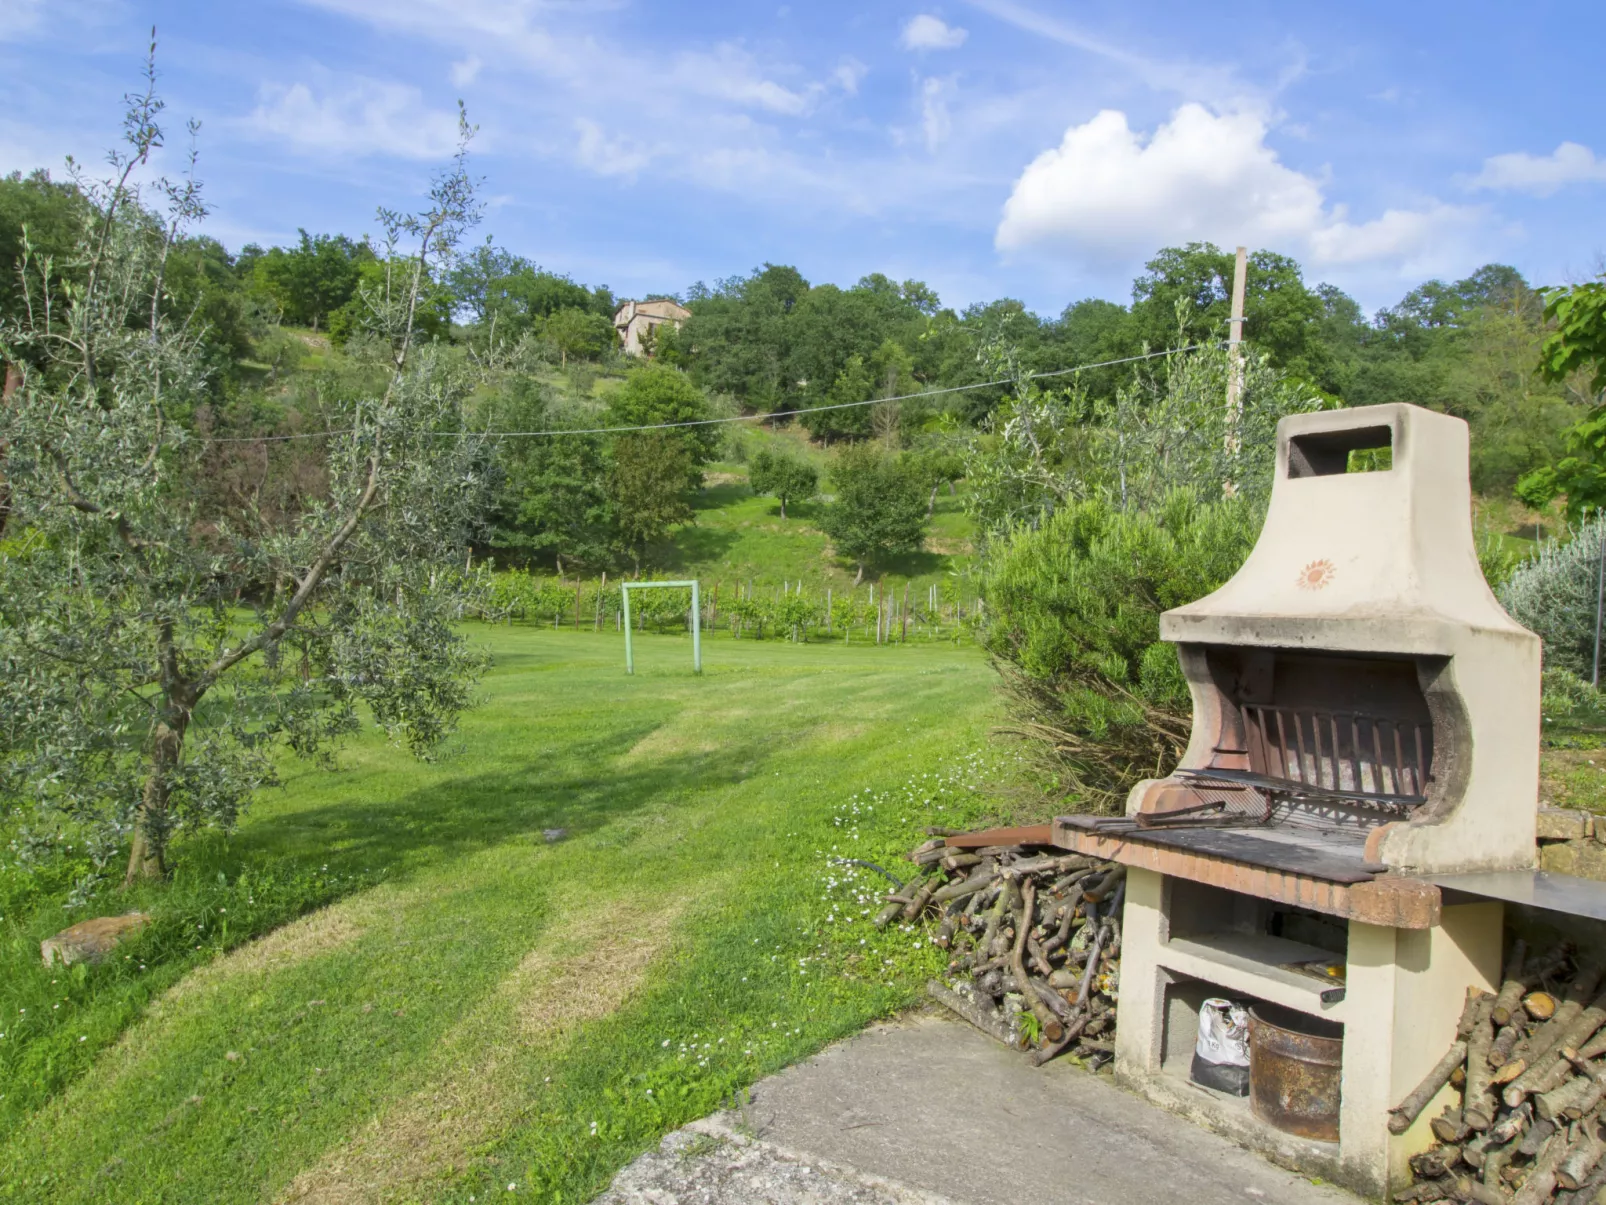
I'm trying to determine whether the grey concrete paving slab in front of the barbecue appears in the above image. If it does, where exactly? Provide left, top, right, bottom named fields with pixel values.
left=601, top=1015, right=1359, bottom=1205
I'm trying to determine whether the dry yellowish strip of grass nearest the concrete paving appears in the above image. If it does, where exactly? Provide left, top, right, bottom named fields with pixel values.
left=278, top=897, right=687, bottom=1205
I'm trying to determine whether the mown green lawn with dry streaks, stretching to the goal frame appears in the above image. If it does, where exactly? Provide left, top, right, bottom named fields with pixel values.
left=0, top=628, right=1001, bottom=1203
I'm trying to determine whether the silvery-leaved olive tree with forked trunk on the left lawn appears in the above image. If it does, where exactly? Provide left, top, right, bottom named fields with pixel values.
left=0, top=72, right=483, bottom=882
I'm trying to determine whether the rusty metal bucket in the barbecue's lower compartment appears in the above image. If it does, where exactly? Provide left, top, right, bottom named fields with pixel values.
left=1249, top=1004, right=1344, bottom=1142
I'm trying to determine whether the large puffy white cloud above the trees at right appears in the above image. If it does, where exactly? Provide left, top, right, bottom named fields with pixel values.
left=994, top=104, right=1479, bottom=267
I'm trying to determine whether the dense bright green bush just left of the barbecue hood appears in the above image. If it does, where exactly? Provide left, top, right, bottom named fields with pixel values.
left=981, top=492, right=1262, bottom=810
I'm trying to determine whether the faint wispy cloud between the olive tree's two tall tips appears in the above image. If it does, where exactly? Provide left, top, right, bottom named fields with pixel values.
left=246, top=77, right=458, bottom=159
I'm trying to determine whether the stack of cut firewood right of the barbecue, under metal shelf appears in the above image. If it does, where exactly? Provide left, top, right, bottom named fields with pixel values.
left=1389, top=942, right=1606, bottom=1205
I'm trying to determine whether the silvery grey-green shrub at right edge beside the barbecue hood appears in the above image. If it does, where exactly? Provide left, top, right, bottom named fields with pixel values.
left=1500, top=516, right=1606, bottom=678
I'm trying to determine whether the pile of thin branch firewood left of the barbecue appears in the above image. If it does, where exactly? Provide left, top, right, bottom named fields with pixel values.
left=875, top=829, right=1126, bottom=1065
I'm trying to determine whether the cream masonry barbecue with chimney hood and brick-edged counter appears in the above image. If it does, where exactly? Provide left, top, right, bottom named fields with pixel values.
left=1052, top=405, right=1540, bottom=1195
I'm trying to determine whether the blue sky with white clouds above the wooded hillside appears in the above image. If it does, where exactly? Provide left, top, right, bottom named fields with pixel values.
left=0, top=0, right=1606, bottom=313
